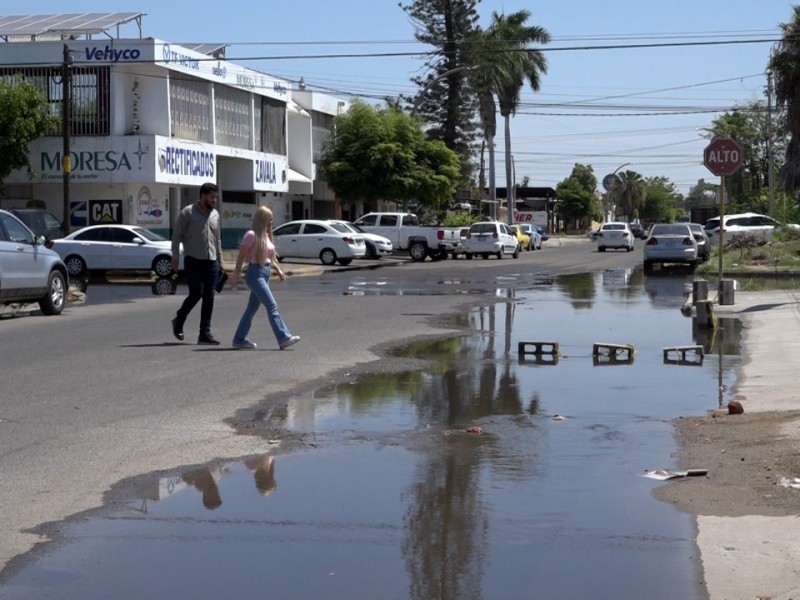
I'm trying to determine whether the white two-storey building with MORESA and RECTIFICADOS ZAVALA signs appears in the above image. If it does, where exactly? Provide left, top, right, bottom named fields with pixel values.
left=0, top=13, right=345, bottom=248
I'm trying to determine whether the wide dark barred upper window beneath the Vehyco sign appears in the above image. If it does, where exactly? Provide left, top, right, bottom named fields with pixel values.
left=0, top=67, right=111, bottom=135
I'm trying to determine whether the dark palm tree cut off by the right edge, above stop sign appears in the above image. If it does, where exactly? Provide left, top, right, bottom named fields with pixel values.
left=769, top=5, right=800, bottom=197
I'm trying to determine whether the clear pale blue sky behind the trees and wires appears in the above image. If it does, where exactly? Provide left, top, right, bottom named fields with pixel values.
left=0, top=0, right=792, bottom=193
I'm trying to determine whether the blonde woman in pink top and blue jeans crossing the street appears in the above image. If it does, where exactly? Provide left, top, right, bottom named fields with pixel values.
left=231, top=206, right=300, bottom=350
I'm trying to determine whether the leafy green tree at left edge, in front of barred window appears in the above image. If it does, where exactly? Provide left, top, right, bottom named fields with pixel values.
left=0, top=79, right=56, bottom=192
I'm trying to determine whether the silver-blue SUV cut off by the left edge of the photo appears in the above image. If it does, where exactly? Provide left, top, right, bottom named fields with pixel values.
left=0, top=210, right=67, bottom=315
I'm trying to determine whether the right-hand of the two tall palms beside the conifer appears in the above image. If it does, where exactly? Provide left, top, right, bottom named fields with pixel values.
left=477, top=10, right=550, bottom=222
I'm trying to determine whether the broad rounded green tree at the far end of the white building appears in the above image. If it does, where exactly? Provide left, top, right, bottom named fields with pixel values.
left=320, top=101, right=459, bottom=210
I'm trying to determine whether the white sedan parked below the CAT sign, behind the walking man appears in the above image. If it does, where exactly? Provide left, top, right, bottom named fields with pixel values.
left=53, top=225, right=183, bottom=277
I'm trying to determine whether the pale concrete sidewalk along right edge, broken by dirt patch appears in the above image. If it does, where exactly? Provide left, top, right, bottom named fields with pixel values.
left=697, top=290, right=800, bottom=600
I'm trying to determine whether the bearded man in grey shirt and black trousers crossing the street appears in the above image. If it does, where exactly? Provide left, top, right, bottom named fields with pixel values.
left=172, top=183, right=222, bottom=346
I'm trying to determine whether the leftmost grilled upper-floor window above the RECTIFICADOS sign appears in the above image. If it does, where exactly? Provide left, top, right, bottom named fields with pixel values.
left=169, top=73, right=214, bottom=143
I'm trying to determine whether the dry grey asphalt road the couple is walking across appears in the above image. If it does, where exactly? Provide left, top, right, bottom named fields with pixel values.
left=0, top=240, right=641, bottom=582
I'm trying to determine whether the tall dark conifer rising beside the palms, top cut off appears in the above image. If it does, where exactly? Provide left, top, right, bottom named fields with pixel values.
left=400, top=0, right=479, bottom=182
